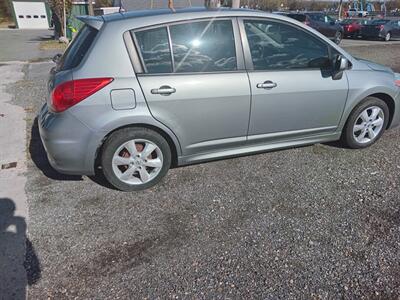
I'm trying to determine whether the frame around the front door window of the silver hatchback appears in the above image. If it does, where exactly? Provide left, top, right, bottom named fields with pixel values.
left=238, top=17, right=350, bottom=73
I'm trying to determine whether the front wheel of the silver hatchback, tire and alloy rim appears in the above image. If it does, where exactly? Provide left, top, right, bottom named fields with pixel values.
left=341, top=97, right=389, bottom=149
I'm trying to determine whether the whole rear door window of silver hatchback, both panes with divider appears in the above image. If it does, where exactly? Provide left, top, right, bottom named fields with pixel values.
left=134, top=20, right=237, bottom=74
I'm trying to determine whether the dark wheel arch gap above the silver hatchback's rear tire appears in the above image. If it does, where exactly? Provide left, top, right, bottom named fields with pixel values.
left=94, top=123, right=180, bottom=169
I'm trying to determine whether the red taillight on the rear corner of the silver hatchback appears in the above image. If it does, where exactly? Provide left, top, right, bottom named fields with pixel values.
left=51, top=78, right=113, bottom=112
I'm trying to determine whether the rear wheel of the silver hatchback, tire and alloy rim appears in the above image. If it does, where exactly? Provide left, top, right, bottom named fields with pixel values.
left=101, top=128, right=171, bottom=192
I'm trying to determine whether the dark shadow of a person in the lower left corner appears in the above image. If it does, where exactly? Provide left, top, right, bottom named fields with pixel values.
left=0, top=198, right=41, bottom=300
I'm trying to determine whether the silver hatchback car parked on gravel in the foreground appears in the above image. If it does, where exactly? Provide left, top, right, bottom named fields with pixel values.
left=39, top=8, right=400, bottom=191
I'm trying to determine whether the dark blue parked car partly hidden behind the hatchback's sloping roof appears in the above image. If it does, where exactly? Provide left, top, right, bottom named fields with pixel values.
left=286, top=12, right=343, bottom=44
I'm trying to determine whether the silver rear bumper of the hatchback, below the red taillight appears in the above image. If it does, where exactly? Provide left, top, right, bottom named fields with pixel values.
left=38, top=104, right=102, bottom=175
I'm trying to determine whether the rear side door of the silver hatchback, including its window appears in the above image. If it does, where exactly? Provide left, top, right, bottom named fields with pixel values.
left=133, top=18, right=250, bottom=155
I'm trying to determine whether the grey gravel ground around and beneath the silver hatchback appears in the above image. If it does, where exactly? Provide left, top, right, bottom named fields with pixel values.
left=11, top=44, right=400, bottom=299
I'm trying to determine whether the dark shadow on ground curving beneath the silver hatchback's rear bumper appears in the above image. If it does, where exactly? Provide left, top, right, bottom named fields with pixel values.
left=29, top=117, right=83, bottom=181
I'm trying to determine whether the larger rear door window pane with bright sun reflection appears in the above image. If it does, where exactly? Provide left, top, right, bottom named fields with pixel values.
left=170, top=20, right=237, bottom=73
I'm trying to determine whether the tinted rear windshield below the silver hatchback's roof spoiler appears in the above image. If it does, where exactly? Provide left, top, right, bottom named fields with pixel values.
left=59, top=25, right=98, bottom=70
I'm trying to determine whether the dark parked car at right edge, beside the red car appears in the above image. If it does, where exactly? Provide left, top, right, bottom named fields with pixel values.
left=360, top=19, right=400, bottom=42
